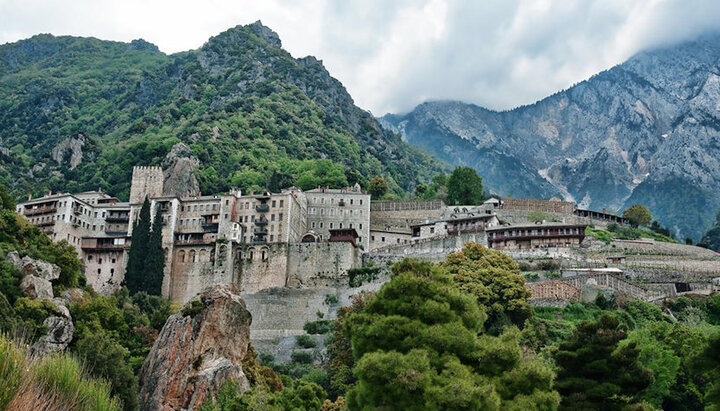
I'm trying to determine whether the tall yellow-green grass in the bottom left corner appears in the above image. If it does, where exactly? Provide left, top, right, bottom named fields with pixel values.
left=0, top=335, right=121, bottom=411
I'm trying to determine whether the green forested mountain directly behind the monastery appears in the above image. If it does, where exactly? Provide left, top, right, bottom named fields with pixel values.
left=0, top=22, right=446, bottom=198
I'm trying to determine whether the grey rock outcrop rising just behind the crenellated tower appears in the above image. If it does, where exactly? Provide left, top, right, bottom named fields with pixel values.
left=162, top=143, right=200, bottom=196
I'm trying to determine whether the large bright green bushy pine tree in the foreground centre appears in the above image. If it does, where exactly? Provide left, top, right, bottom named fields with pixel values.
left=343, top=260, right=560, bottom=410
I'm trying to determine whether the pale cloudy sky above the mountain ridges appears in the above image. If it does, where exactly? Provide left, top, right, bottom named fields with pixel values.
left=0, top=0, right=720, bottom=115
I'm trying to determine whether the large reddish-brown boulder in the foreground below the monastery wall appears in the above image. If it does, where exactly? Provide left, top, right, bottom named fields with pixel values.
left=140, top=285, right=252, bottom=410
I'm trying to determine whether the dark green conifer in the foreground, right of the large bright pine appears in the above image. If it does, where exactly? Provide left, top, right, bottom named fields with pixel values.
left=555, top=313, right=652, bottom=410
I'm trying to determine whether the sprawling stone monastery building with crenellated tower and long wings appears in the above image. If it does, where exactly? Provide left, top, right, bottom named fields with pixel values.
left=17, top=167, right=618, bottom=302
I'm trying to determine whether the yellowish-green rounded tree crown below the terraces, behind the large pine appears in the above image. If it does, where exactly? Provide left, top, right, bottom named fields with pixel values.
left=441, top=243, right=532, bottom=335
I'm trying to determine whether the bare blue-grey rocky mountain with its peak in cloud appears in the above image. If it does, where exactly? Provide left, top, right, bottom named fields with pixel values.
left=381, top=34, right=720, bottom=240
